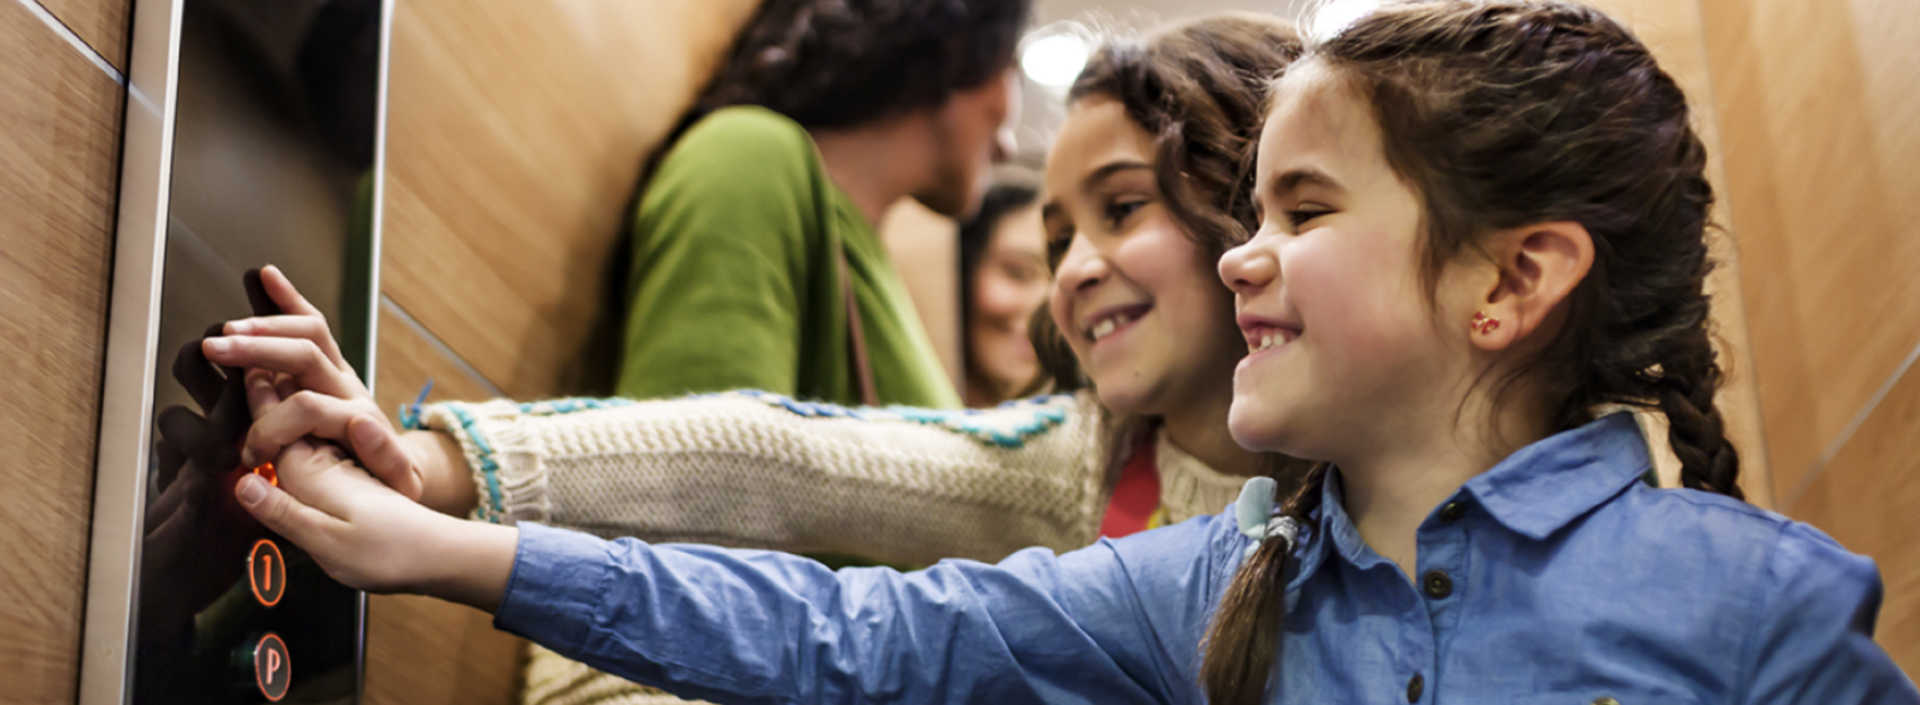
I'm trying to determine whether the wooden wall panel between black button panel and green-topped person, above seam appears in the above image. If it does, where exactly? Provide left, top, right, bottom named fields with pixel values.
left=382, top=0, right=755, bottom=398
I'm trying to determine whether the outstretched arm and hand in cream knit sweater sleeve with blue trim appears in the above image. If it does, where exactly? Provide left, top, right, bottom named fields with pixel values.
left=207, top=269, right=1121, bottom=565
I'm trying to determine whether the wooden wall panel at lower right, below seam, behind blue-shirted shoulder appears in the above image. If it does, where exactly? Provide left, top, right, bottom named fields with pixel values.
left=1766, top=367, right=1920, bottom=676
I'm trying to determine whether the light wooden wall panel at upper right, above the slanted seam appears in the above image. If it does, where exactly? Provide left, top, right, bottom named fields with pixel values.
left=1701, top=0, right=1920, bottom=509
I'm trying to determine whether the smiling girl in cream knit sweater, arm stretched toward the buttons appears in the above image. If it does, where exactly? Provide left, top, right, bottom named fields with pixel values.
left=215, top=15, right=1302, bottom=701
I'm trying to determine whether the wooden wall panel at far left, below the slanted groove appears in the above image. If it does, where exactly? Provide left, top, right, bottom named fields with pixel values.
left=0, top=2, right=123, bottom=703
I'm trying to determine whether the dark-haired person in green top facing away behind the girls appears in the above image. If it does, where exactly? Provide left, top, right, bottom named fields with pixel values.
left=618, top=0, right=1029, bottom=407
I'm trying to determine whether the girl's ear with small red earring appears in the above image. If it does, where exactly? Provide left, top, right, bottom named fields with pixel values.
left=1461, top=221, right=1594, bottom=352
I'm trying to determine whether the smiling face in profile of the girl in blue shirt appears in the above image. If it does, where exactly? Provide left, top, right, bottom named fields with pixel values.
left=1219, top=63, right=1475, bottom=463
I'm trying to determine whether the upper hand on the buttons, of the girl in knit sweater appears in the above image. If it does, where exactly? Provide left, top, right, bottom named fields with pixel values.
left=204, top=267, right=453, bottom=499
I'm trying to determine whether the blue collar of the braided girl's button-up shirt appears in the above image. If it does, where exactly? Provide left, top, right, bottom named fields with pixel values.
left=1288, top=413, right=1651, bottom=588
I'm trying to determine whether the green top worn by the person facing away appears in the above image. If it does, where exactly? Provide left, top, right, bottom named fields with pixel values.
left=620, top=108, right=960, bottom=407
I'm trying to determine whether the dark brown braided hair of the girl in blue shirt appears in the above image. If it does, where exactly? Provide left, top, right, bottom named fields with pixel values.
left=1200, top=0, right=1741, bottom=705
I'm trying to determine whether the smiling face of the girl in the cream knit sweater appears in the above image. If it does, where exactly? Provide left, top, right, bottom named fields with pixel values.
left=1043, top=94, right=1242, bottom=415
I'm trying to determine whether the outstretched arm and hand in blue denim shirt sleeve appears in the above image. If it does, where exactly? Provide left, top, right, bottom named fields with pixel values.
left=236, top=394, right=1244, bottom=703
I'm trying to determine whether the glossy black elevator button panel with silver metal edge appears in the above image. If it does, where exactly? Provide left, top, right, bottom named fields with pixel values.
left=81, top=0, right=390, bottom=703
